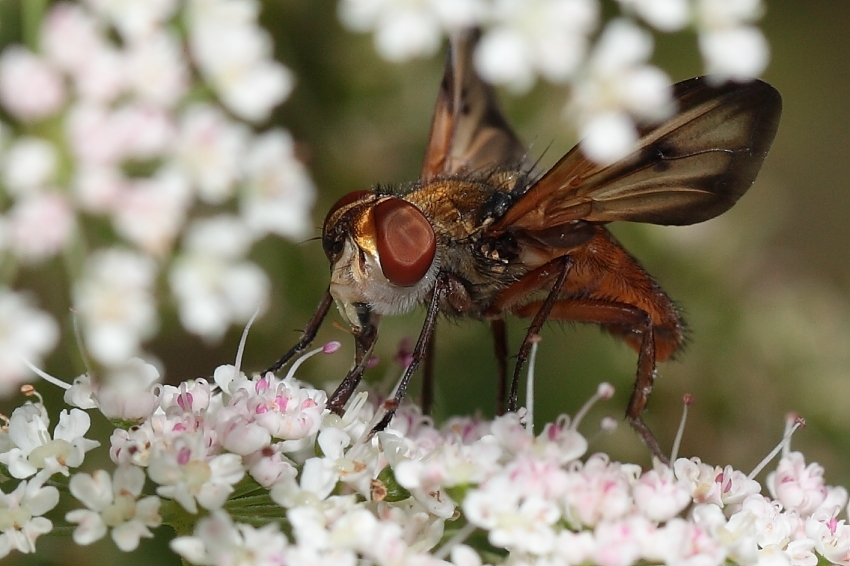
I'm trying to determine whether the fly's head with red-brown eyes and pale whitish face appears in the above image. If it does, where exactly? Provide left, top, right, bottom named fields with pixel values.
left=322, top=191, right=439, bottom=329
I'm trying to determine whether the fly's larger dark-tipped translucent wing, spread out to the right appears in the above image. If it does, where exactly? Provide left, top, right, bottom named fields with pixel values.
left=491, top=77, right=782, bottom=232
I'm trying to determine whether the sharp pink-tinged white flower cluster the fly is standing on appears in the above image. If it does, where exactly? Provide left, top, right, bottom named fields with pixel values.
left=0, top=343, right=850, bottom=566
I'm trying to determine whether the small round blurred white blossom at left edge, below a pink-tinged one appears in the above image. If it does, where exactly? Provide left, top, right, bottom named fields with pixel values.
left=2, top=136, right=58, bottom=196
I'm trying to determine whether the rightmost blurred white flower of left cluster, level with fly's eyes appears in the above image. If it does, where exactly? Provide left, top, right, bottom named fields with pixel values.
left=239, top=129, right=316, bottom=238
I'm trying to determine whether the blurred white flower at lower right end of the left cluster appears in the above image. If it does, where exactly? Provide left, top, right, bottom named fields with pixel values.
left=169, top=216, right=271, bottom=341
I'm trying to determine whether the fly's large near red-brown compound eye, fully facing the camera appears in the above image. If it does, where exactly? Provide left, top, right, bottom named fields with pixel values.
left=374, top=198, right=437, bottom=287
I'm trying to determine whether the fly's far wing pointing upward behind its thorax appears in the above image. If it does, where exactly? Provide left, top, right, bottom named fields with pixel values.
left=421, top=30, right=526, bottom=181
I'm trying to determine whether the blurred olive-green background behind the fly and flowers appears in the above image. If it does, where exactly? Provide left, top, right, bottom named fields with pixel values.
left=0, top=0, right=850, bottom=563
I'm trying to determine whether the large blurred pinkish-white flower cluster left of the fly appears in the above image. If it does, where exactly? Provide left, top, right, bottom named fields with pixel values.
left=0, top=0, right=315, bottom=394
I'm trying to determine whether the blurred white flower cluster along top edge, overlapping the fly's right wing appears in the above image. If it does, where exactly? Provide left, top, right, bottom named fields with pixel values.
left=340, top=0, right=769, bottom=163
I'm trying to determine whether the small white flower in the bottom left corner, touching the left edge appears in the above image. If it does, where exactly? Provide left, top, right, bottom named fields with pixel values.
left=0, top=474, right=59, bottom=558
